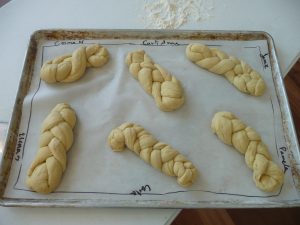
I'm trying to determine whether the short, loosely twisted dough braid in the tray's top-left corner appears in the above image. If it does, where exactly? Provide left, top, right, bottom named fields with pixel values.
left=41, top=44, right=109, bottom=83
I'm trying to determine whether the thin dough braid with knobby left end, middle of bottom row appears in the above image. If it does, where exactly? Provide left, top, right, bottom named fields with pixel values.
left=108, top=123, right=198, bottom=187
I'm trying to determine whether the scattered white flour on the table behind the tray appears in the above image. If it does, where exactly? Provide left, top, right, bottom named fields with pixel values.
left=142, top=0, right=214, bottom=29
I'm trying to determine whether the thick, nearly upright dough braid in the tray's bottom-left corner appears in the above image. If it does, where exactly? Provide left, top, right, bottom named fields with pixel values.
left=26, top=103, right=76, bottom=194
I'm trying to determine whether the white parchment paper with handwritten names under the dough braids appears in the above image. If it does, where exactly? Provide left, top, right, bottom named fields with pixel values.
left=5, top=37, right=299, bottom=207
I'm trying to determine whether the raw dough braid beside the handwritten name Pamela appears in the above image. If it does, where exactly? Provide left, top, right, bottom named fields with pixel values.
left=211, top=112, right=284, bottom=192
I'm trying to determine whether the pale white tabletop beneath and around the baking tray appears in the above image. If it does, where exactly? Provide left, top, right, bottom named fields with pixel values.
left=0, top=0, right=300, bottom=224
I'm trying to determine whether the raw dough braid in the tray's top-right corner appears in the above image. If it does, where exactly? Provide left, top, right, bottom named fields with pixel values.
left=186, top=44, right=266, bottom=96
